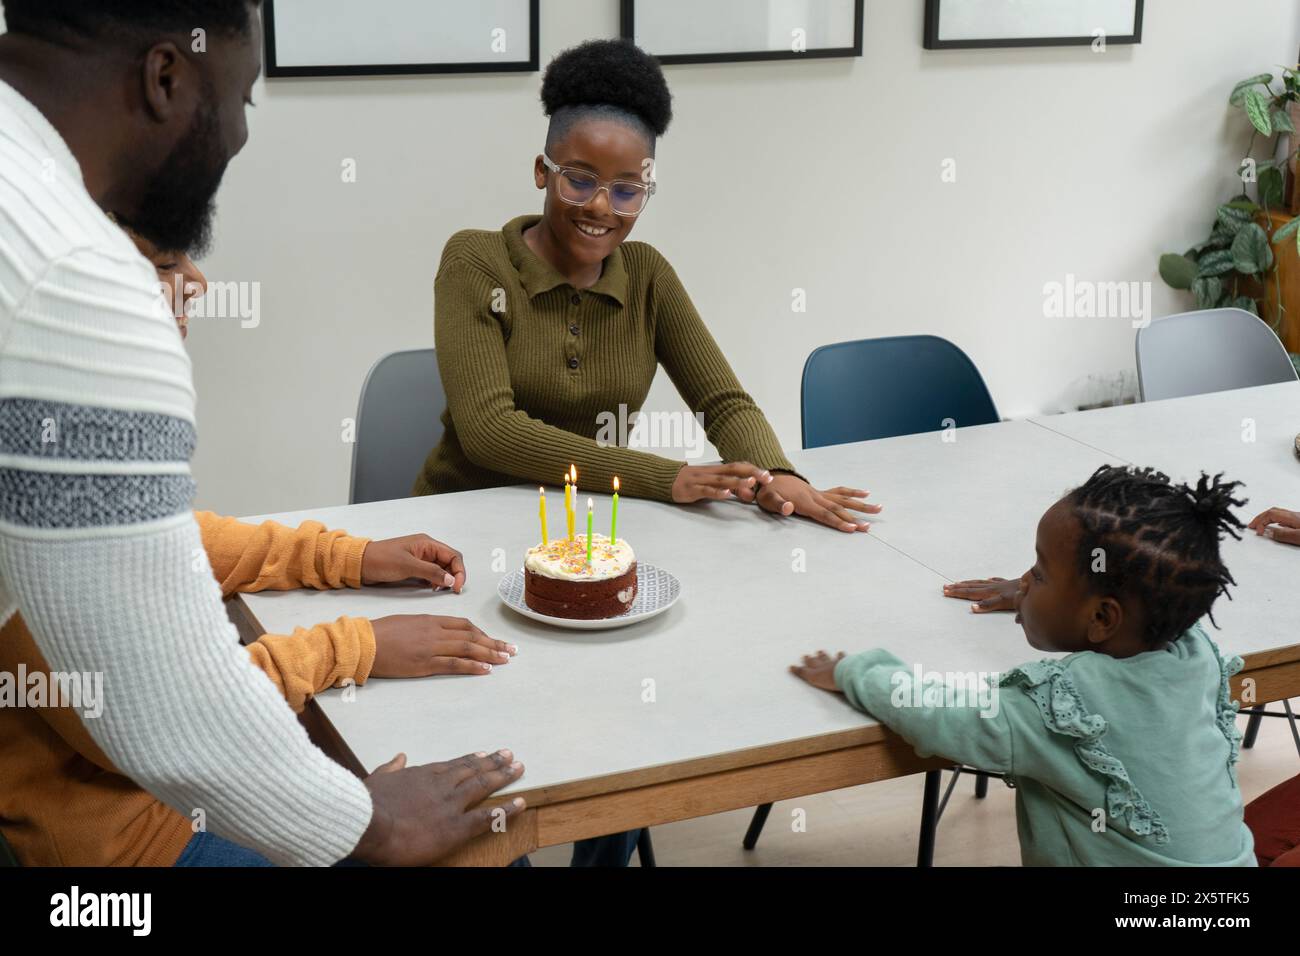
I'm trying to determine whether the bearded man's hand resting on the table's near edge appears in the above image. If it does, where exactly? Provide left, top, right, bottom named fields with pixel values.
left=352, top=750, right=525, bottom=866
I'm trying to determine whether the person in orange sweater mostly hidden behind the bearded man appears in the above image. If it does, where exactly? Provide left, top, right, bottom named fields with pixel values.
left=0, top=512, right=516, bottom=866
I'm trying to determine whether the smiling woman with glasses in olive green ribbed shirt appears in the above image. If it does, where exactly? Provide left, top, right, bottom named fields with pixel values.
left=415, top=40, right=880, bottom=532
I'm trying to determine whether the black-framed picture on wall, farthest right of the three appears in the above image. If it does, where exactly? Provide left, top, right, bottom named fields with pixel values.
left=926, top=0, right=1145, bottom=49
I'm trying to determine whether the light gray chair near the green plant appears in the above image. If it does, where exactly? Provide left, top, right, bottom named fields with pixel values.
left=1138, top=308, right=1296, bottom=402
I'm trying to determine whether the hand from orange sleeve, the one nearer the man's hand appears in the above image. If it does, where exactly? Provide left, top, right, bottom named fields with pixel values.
left=371, top=614, right=519, bottom=678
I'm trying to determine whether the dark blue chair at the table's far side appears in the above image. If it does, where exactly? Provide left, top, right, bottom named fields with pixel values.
left=741, top=336, right=1001, bottom=866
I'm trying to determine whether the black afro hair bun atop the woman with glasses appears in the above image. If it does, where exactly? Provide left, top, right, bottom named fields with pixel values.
left=542, top=40, right=672, bottom=137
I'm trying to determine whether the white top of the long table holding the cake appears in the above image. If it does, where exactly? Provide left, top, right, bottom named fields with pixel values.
left=244, top=386, right=1300, bottom=791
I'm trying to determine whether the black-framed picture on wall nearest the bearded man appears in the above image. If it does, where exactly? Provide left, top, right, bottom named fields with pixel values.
left=263, top=0, right=540, bottom=78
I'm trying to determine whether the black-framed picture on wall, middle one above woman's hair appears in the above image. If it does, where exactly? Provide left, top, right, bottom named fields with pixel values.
left=620, top=0, right=863, bottom=64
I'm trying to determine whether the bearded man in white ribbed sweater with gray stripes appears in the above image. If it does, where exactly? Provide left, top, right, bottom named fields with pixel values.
left=0, top=0, right=523, bottom=865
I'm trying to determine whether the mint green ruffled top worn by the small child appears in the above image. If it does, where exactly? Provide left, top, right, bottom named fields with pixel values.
left=835, top=624, right=1256, bottom=866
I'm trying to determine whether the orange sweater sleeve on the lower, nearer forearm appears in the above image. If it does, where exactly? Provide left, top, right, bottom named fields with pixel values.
left=248, top=618, right=374, bottom=713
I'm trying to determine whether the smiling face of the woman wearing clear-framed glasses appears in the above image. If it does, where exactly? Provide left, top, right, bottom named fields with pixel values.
left=533, top=118, right=653, bottom=269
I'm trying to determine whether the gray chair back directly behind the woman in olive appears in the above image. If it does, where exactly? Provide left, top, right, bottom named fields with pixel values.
left=348, top=349, right=447, bottom=505
